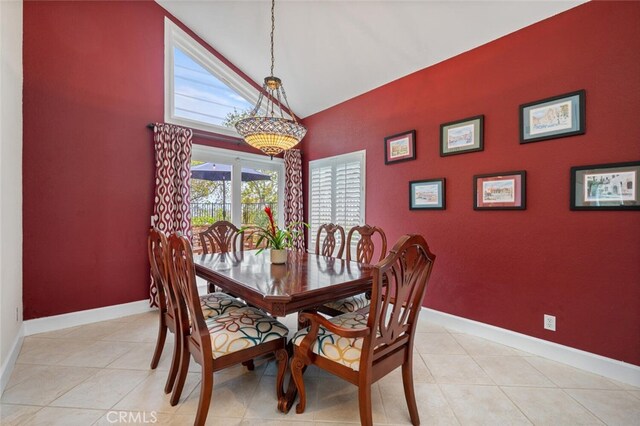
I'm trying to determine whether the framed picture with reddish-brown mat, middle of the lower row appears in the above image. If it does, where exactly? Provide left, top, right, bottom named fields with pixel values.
left=473, top=170, right=526, bottom=210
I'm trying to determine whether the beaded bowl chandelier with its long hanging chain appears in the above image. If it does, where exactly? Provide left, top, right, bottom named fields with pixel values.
left=236, top=0, right=307, bottom=158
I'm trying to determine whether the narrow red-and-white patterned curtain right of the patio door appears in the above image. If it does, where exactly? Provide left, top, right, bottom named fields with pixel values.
left=284, top=149, right=305, bottom=250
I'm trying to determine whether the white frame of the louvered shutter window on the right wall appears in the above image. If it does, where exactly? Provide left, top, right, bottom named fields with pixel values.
left=307, top=150, right=367, bottom=252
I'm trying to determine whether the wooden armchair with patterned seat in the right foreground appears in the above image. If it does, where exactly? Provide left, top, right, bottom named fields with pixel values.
left=291, top=235, right=436, bottom=425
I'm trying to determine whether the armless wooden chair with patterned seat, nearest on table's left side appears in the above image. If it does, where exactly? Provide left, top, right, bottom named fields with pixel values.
left=169, top=234, right=289, bottom=426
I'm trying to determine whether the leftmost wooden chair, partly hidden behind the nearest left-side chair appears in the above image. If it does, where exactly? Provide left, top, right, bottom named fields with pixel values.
left=147, top=228, right=247, bottom=393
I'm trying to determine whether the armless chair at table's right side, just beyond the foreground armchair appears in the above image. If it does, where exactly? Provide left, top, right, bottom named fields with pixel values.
left=318, top=225, right=387, bottom=316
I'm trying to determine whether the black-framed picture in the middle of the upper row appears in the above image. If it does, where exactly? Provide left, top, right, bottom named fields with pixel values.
left=440, top=115, right=484, bottom=157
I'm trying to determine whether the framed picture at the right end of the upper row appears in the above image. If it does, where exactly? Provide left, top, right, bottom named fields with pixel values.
left=520, top=90, right=585, bottom=143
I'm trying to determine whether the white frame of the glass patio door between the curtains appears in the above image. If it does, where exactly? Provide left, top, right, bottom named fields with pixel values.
left=191, top=144, right=285, bottom=227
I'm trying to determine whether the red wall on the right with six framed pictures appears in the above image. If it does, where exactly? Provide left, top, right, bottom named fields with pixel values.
left=303, top=2, right=640, bottom=365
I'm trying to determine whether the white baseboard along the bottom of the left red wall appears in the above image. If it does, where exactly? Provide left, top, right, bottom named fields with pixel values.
left=24, top=300, right=153, bottom=336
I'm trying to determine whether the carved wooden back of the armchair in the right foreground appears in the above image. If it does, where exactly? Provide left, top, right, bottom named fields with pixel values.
left=360, top=235, right=436, bottom=375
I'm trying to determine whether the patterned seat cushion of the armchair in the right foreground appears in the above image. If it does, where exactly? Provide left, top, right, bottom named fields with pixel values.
left=293, top=310, right=367, bottom=371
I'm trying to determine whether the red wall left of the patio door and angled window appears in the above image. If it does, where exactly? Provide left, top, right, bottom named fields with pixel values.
left=23, top=1, right=258, bottom=319
